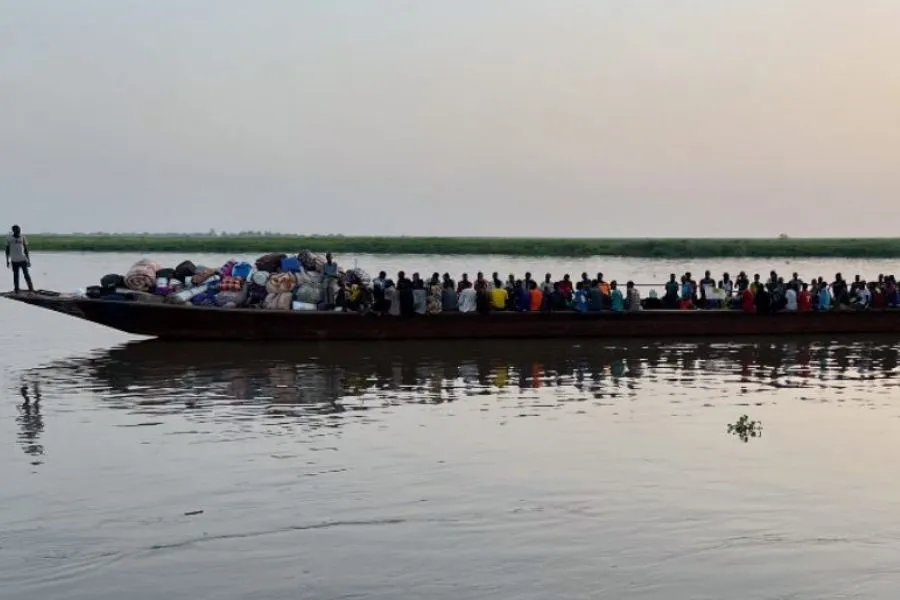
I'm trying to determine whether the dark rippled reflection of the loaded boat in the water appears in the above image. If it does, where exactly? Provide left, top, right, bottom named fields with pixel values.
left=19, top=336, right=898, bottom=427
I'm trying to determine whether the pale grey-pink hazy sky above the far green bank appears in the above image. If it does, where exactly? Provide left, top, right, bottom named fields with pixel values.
left=0, top=0, right=900, bottom=237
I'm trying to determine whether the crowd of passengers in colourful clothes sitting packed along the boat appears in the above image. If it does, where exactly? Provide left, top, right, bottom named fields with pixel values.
left=338, top=271, right=900, bottom=316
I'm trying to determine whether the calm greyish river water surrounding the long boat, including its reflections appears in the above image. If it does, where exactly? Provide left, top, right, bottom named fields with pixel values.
left=0, top=254, right=900, bottom=600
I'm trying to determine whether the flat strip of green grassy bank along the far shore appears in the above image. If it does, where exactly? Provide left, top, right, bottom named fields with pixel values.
left=22, top=234, right=900, bottom=259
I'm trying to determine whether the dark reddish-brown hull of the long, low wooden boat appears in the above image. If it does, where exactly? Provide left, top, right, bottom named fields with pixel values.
left=2, top=292, right=900, bottom=341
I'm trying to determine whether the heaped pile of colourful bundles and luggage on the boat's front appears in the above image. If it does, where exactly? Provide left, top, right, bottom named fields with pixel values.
left=85, top=250, right=371, bottom=310
